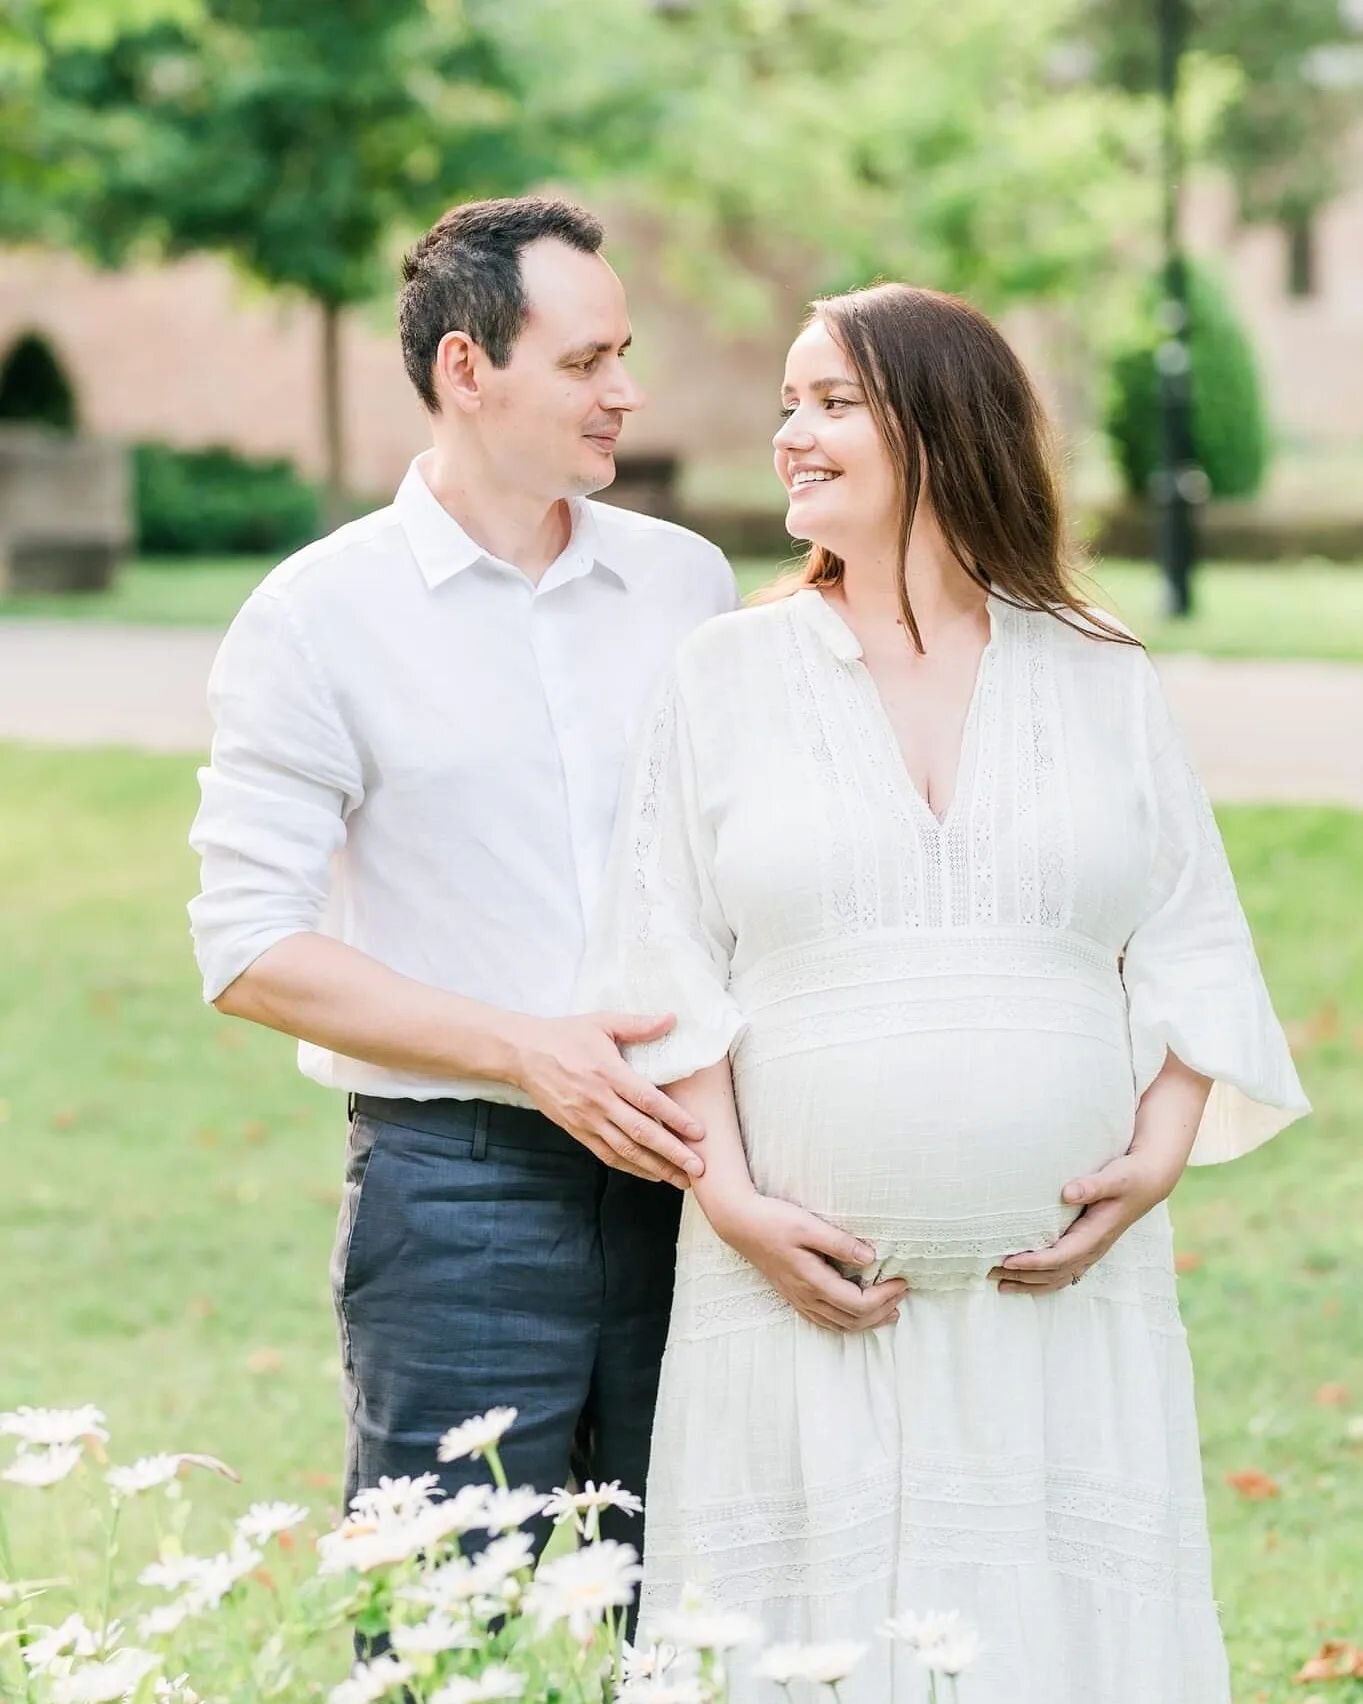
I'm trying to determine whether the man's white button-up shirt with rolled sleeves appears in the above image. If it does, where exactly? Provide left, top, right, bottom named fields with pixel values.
left=189, top=457, right=736, bottom=1101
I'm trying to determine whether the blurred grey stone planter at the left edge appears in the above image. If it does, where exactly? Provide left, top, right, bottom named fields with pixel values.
left=0, top=426, right=133, bottom=591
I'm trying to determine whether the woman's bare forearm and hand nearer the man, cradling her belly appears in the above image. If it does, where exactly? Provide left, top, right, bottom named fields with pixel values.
left=670, top=1058, right=908, bottom=1331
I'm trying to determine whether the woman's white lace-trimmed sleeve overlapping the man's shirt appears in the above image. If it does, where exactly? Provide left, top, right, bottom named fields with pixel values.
left=576, top=676, right=743, bottom=1084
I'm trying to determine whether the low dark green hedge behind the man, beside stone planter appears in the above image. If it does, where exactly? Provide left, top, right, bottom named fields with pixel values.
left=133, top=443, right=319, bottom=556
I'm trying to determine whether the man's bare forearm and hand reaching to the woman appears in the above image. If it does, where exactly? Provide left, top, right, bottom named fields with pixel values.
left=213, top=930, right=705, bottom=1188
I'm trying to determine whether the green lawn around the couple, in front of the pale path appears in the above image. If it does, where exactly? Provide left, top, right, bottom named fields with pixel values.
left=0, top=748, right=1363, bottom=1704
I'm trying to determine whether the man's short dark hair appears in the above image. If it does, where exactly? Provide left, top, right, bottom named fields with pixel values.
left=397, top=196, right=605, bottom=414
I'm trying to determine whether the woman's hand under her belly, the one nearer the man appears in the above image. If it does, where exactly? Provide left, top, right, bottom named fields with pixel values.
left=716, top=1193, right=908, bottom=1331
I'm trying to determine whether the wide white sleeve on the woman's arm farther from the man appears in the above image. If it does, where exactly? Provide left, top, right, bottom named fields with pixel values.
left=1123, top=659, right=1310, bottom=1166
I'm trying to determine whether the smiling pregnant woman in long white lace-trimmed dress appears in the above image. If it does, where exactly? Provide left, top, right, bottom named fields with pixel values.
left=584, top=285, right=1307, bottom=1704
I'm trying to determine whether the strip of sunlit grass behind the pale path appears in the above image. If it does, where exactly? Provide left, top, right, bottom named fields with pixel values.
left=0, top=557, right=1363, bottom=661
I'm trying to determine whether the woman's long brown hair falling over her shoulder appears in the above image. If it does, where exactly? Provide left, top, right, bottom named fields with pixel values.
left=767, top=285, right=1140, bottom=651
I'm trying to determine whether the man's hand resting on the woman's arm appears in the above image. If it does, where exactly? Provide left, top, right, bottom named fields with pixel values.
left=511, top=1012, right=705, bottom=1189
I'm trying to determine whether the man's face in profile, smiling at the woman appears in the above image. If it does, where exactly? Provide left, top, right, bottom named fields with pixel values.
left=479, top=239, right=644, bottom=499
